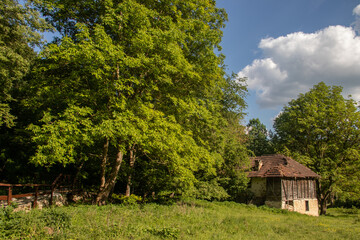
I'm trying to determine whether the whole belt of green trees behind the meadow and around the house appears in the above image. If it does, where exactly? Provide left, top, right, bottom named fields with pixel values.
left=0, top=0, right=360, bottom=210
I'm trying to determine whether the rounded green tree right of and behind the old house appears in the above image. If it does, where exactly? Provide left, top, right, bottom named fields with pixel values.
left=274, top=82, right=360, bottom=214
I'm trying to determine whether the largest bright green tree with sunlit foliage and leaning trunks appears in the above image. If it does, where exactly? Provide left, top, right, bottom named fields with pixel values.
left=24, top=0, right=249, bottom=204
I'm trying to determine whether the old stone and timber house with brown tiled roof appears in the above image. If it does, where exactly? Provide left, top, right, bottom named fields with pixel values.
left=248, top=154, right=320, bottom=216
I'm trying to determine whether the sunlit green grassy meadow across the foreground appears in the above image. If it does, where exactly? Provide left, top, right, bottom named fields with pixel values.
left=0, top=201, right=360, bottom=240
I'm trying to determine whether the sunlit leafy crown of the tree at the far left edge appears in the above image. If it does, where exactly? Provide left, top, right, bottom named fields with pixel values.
left=0, top=0, right=49, bottom=127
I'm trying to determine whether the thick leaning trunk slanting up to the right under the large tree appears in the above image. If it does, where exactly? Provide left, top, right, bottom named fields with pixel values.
left=96, top=148, right=124, bottom=206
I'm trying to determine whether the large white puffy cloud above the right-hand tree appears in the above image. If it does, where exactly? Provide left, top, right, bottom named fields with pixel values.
left=238, top=5, right=360, bottom=108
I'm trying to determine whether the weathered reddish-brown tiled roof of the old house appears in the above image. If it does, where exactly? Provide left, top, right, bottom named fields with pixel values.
left=248, top=154, right=320, bottom=178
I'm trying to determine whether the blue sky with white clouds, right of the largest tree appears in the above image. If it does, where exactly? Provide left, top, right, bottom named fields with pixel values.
left=217, top=0, right=360, bottom=131
